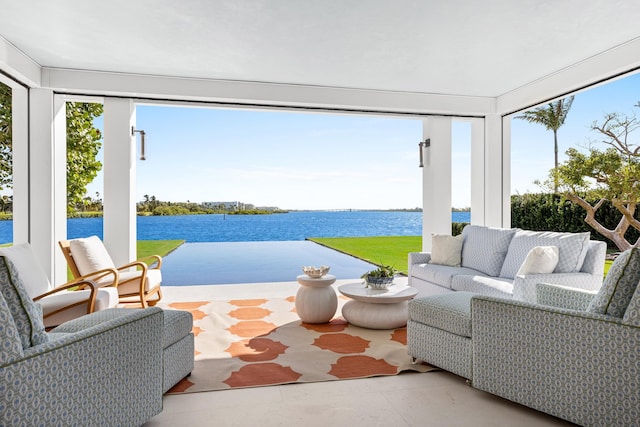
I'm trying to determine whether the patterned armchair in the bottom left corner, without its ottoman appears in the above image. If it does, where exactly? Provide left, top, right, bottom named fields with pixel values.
left=0, top=256, right=164, bottom=426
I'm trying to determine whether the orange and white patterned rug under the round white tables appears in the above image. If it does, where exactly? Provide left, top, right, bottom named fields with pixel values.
left=158, top=297, right=436, bottom=393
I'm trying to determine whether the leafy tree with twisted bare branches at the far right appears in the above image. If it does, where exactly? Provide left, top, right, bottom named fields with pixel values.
left=547, top=104, right=640, bottom=251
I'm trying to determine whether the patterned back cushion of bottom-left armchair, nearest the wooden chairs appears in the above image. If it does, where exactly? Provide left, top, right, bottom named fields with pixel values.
left=0, top=256, right=49, bottom=349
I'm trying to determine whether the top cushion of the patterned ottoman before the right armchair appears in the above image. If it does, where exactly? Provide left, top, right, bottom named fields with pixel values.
left=409, top=292, right=474, bottom=337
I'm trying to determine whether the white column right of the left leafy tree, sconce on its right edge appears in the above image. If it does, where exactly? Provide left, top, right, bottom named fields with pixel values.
left=103, top=98, right=136, bottom=265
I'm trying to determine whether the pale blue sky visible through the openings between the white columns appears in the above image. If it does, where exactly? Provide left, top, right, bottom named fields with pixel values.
left=88, top=75, right=640, bottom=209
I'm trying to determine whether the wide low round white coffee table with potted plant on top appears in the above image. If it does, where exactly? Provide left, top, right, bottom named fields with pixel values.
left=338, top=283, right=418, bottom=329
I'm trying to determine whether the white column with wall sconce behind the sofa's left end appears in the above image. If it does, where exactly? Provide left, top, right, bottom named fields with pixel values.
left=422, top=117, right=451, bottom=251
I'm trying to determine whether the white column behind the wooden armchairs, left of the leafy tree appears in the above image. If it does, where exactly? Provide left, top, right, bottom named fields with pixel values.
left=29, top=89, right=67, bottom=284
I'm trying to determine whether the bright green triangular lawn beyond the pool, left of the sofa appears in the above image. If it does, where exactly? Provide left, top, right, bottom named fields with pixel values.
left=307, top=236, right=422, bottom=274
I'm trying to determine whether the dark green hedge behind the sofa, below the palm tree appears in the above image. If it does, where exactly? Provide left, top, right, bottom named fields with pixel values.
left=511, top=194, right=640, bottom=248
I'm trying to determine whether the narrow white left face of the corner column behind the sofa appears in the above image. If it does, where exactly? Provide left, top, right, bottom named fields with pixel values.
left=471, top=119, right=486, bottom=225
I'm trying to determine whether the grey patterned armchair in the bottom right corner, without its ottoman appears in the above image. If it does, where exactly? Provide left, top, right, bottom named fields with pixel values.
left=471, top=248, right=640, bottom=426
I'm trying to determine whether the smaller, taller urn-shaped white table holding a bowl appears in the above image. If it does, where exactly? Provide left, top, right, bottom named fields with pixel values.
left=296, top=274, right=338, bottom=323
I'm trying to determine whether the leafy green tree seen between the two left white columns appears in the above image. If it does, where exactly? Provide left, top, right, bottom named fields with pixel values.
left=66, top=102, right=103, bottom=210
